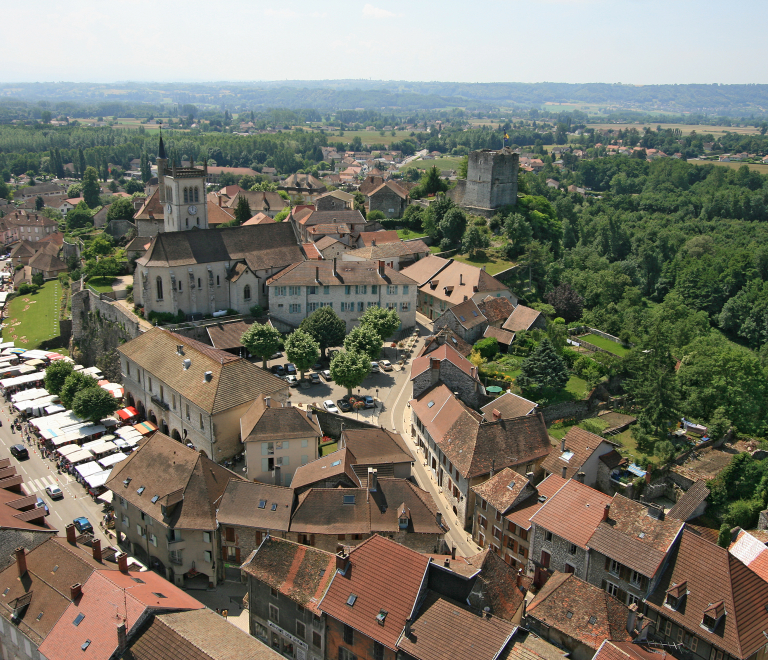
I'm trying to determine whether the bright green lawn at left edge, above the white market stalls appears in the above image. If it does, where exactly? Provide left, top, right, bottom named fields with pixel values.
left=3, top=280, right=61, bottom=349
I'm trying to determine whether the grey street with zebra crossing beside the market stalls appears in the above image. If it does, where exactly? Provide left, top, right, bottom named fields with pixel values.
left=0, top=402, right=114, bottom=547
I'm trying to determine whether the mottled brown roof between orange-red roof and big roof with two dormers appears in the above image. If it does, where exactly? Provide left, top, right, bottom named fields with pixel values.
left=588, top=494, right=683, bottom=577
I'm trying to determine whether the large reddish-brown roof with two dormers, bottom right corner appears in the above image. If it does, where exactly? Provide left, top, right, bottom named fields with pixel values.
left=646, top=529, right=768, bottom=659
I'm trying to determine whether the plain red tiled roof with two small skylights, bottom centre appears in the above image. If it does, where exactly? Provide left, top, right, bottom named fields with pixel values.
left=320, top=535, right=430, bottom=651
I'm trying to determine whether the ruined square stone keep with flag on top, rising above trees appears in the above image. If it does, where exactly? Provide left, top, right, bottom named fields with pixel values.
left=461, top=147, right=520, bottom=216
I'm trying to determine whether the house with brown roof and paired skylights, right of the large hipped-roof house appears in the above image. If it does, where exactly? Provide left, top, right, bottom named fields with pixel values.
left=216, top=479, right=295, bottom=565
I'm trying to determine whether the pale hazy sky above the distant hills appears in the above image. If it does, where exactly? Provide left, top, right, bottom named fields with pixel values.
left=6, top=0, right=768, bottom=84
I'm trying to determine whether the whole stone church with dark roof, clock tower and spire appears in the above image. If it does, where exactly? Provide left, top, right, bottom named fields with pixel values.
left=133, top=136, right=305, bottom=315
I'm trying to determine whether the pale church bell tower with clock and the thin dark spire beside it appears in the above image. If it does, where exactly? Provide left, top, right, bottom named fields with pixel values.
left=157, top=136, right=208, bottom=232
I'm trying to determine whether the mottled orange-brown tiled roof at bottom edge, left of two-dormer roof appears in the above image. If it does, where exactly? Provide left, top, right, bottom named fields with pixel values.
left=526, top=572, right=632, bottom=649
